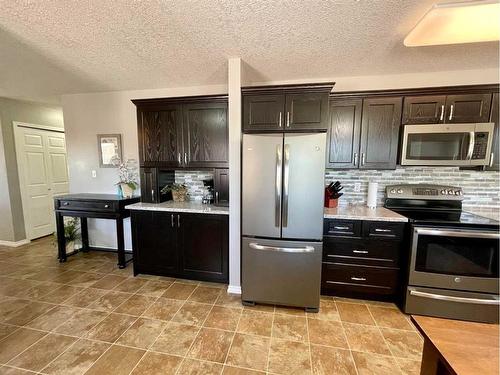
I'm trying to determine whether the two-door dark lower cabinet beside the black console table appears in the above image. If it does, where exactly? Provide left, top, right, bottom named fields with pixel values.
left=131, top=210, right=229, bottom=282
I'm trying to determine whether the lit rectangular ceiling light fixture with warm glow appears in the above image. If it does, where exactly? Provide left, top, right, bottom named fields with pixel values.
left=404, top=0, right=500, bottom=47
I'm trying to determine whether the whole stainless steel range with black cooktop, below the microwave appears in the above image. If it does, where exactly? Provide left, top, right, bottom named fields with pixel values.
left=385, top=184, right=500, bottom=323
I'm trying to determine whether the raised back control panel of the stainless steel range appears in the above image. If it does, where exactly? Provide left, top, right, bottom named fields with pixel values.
left=385, top=184, right=464, bottom=201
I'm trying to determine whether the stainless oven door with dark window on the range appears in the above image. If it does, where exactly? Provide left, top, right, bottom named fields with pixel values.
left=409, top=227, right=500, bottom=293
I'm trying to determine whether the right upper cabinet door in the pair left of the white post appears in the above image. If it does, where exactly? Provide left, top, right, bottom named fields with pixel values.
left=183, top=102, right=229, bottom=168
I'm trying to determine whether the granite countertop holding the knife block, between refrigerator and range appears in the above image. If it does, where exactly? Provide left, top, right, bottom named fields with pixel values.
left=324, top=205, right=408, bottom=222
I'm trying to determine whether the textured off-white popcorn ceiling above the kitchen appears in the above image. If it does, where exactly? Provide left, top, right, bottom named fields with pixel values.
left=0, top=0, right=498, bottom=103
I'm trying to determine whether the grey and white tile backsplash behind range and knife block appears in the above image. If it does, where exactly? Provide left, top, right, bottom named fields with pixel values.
left=325, top=167, right=500, bottom=217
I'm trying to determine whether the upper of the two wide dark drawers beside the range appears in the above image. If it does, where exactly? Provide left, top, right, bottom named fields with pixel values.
left=323, top=238, right=400, bottom=267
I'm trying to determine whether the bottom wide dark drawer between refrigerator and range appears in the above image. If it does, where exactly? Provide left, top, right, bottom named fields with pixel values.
left=321, top=263, right=399, bottom=294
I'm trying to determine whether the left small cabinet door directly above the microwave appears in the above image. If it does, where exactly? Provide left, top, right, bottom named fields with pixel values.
left=402, top=95, right=446, bottom=124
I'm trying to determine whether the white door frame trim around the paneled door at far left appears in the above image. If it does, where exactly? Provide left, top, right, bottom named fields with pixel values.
left=12, top=121, right=69, bottom=241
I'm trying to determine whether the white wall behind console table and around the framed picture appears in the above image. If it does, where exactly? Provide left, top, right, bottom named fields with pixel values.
left=62, top=85, right=227, bottom=249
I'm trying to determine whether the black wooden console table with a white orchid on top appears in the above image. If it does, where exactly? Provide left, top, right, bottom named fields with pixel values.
left=54, top=193, right=140, bottom=268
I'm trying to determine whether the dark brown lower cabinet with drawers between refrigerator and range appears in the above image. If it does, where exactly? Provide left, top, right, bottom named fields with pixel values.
left=321, top=219, right=406, bottom=300
